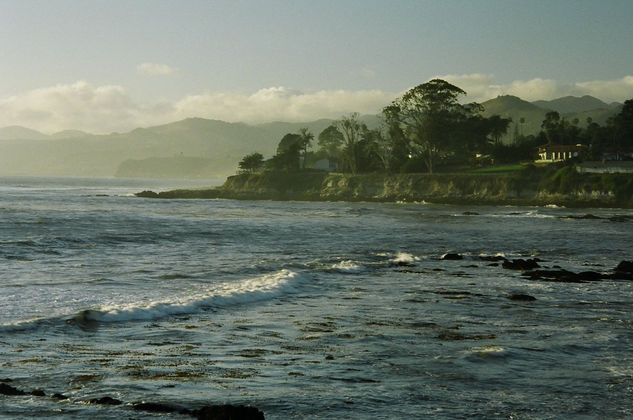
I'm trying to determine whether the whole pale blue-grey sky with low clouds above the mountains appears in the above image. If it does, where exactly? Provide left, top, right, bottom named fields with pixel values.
left=0, top=0, right=633, bottom=133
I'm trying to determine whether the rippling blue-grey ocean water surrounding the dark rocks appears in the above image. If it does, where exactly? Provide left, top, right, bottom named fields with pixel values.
left=0, top=177, right=633, bottom=419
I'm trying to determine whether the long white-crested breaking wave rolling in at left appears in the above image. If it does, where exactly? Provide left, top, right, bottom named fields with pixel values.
left=0, top=269, right=300, bottom=332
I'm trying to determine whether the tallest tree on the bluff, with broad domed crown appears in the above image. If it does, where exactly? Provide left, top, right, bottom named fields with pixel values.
left=383, top=79, right=471, bottom=173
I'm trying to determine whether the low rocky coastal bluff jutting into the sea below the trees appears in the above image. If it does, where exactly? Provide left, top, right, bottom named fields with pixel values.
left=136, top=166, right=633, bottom=208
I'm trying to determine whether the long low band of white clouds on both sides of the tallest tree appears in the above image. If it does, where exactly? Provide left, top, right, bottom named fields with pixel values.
left=0, top=74, right=633, bottom=133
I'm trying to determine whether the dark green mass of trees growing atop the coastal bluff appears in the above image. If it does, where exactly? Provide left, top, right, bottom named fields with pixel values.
left=240, top=79, right=633, bottom=179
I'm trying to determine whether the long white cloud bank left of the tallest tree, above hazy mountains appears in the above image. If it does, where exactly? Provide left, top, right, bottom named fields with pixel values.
left=0, top=81, right=396, bottom=133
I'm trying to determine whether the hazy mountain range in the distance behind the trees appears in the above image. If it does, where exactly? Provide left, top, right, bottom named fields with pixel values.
left=0, top=96, right=621, bottom=178
